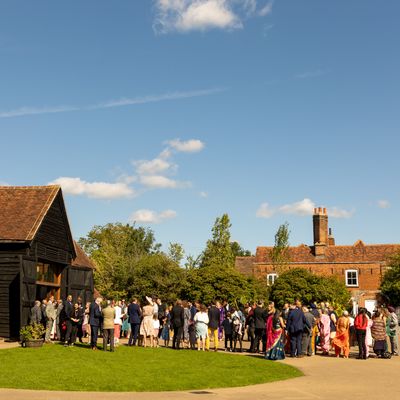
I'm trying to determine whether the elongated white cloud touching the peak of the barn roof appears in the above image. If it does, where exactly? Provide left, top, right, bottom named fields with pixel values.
left=49, top=177, right=135, bottom=199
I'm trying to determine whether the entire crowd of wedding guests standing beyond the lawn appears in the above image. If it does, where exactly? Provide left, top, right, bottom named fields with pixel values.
left=31, top=296, right=399, bottom=360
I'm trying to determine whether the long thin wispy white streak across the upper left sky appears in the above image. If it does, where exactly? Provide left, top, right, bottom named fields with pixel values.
left=0, top=88, right=226, bottom=118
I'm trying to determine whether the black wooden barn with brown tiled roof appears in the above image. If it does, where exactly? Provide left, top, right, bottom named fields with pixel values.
left=0, top=186, right=94, bottom=338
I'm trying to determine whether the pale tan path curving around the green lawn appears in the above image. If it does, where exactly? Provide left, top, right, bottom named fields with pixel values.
left=0, top=356, right=400, bottom=400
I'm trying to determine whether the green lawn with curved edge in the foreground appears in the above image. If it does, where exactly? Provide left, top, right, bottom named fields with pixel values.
left=0, top=344, right=302, bottom=392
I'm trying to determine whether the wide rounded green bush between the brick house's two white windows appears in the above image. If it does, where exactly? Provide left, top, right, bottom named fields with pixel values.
left=270, top=268, right=350, bottom=307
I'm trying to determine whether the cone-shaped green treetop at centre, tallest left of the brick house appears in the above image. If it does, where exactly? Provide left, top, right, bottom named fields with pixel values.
left=201, top=214, right=235, bottom=267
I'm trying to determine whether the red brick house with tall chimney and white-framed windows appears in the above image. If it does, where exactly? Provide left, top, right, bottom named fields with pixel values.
left=236, top=208, right=400, bottom=310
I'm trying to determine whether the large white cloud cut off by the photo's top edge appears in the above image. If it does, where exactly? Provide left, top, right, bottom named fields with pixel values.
left=153, top=0, right=272, bottom=33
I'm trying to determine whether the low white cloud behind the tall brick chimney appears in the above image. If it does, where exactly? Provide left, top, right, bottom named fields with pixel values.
left=256, top=198, right=354, bottom=218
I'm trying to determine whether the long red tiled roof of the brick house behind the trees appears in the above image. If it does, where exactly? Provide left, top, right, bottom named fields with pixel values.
left=255, top=240, right=400, bottom=264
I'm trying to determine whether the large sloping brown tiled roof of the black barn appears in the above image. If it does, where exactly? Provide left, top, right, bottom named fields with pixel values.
left=0, top=185, right=61, bottom=241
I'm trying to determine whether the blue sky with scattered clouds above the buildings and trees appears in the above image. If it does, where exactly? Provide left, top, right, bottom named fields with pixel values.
left=0, top=0, right=400, bottom=255
